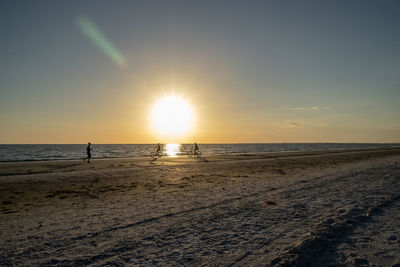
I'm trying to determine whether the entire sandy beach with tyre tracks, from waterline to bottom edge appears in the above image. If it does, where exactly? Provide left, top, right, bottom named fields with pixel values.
left=0, top=149, right=400, bottom=266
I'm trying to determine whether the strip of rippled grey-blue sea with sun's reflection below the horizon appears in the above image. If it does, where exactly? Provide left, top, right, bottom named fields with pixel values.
left=0, top=143, right=399, bottom=162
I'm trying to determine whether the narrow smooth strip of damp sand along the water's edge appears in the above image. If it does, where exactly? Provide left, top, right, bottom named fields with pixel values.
left=0, top=148, right=400, bottom=181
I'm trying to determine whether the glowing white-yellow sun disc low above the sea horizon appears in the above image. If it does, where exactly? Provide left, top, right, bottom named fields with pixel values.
left=151, top=95, right=194, bottom=137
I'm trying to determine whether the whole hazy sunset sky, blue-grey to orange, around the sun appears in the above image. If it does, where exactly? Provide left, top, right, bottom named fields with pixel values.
left=0, top=0, right=400, bottom=144
